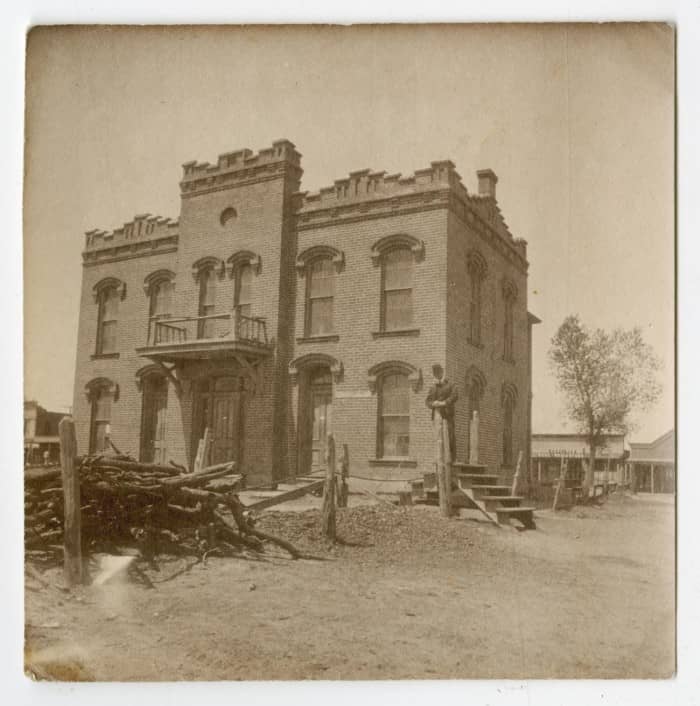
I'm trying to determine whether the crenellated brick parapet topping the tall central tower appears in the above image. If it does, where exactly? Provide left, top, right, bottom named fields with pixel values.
left=180, top=139, right=302, bottom=198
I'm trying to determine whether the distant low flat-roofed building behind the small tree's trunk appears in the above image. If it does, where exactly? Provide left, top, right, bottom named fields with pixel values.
left=531, top=434, right=628, bottom=486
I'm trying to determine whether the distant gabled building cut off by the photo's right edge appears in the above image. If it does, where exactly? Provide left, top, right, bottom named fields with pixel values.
left=627, top=429, right=676, bottom=493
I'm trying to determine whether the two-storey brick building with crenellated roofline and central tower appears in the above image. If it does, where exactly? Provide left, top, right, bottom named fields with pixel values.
left=74, top=140, right=537, bottom=486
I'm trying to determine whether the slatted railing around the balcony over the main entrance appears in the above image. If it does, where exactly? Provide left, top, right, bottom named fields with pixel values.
left=146, top=312, right=269, bottom=347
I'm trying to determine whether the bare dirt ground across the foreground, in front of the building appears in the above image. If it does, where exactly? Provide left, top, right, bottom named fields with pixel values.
left=25, top=495, right=675, bottom=681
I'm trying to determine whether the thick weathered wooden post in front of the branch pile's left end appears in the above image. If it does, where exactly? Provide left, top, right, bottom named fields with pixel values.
left=58, top=417, right=83, bottom=588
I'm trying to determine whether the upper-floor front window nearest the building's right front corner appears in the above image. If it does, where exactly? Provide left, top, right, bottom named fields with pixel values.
left=381, top=248, right=413, bottom=331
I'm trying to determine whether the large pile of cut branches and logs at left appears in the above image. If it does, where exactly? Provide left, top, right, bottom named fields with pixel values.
left=25, top=455, right=301, bottom=561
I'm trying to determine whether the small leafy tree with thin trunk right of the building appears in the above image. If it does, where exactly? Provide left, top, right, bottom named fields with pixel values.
left=549, top=316, right=661, bottom=489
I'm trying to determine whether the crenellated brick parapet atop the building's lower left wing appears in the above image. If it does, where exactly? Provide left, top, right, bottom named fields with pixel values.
left=83, top=213, right=179, bottom=265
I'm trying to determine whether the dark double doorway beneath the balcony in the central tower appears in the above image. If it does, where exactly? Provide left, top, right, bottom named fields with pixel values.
left=191, top=376, right=245, bottom=468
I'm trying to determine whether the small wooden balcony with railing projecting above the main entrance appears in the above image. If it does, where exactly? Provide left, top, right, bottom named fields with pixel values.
left=136, top=313, right=273, bottom=363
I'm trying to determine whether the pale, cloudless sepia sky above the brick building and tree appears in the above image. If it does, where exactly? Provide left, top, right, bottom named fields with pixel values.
left=24, top=24, right=674, bottom=440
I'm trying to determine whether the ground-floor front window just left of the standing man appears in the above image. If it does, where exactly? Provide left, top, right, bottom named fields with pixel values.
left=377, top=373, right=410, bottom=458
